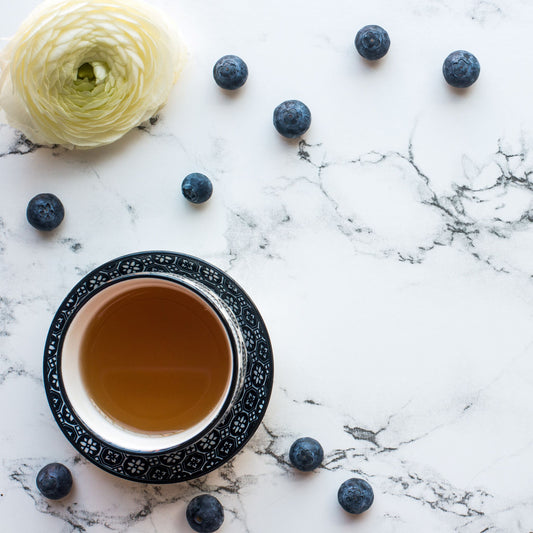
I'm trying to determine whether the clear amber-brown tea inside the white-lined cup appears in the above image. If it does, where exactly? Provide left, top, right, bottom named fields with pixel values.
left=81, top=278, right=232, bottom=434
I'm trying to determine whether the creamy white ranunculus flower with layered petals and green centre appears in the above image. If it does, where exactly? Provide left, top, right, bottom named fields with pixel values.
left=0, top=0, right=185, bottom=148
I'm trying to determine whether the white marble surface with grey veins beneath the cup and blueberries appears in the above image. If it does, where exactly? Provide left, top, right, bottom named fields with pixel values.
left=0, top=0, right=533, bottom=533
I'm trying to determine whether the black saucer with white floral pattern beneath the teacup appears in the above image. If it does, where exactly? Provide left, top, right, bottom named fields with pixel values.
left=43, top=251, right=274, bottom=484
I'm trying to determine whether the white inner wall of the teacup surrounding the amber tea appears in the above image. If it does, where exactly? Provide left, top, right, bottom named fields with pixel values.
left=59, top=275, right=236, bottom=452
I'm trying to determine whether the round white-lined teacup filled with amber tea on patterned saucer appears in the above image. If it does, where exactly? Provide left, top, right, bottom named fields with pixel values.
left=58, top=272, right=247, bottom=453
